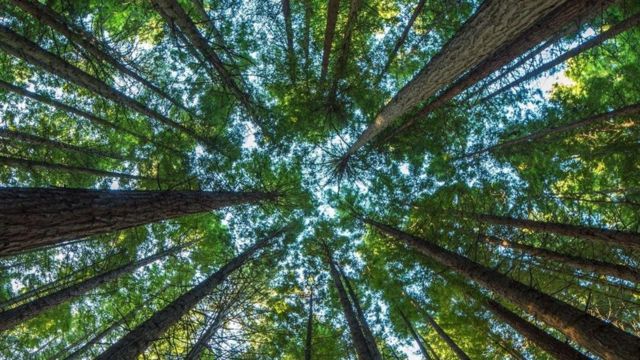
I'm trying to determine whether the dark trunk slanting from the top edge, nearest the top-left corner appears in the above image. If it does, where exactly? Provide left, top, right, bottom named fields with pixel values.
left=11, top=0, right=189, bottom=112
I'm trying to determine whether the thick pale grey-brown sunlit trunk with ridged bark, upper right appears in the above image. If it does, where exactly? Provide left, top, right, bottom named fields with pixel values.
left=344, top=0, right=565, bottom=159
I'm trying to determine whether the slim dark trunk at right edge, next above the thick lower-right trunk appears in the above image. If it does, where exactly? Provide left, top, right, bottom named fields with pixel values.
left=482, top=235, right=640, bottom=284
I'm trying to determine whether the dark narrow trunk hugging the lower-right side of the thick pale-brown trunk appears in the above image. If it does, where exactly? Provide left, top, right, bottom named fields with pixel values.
left=383, top=0, right=615, bottom=142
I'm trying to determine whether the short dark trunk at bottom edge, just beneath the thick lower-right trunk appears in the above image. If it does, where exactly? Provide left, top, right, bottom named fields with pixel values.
left=486, top=300, right=589, bottom=360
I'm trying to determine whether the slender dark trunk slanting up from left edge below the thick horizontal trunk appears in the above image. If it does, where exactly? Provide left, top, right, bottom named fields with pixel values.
left=0, top=243, right=191, bottom=331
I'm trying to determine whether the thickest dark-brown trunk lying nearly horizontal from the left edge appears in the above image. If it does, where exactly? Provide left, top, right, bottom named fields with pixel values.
left=0, top=188, right=277, bottom=255
